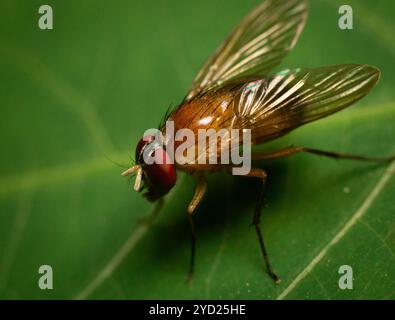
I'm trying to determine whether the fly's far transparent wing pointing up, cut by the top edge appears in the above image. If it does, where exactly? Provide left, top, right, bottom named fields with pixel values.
left=185, top=0, right=308, bottom=100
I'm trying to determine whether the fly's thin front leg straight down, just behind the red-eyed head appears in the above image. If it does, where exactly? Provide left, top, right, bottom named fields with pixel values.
left=187, top=175, right=207, bottom=282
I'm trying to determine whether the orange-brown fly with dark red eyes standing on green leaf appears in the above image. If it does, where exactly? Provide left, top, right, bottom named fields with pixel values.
left=123, top=0, right=394, bottom=282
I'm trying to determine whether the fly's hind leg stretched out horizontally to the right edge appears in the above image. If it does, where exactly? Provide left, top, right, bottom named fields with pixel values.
left=251, top=146, right=395, bottom=163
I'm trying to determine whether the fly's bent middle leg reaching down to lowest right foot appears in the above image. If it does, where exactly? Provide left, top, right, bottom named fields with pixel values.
left=235, top=169, right=281, bottom=283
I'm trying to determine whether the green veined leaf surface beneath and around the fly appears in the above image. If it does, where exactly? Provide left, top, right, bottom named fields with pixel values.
left=0, top=0, right=395, bottom=299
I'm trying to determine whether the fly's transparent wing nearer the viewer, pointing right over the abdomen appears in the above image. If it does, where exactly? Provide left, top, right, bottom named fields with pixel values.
left=234, top=65, right=380, bottom=143
